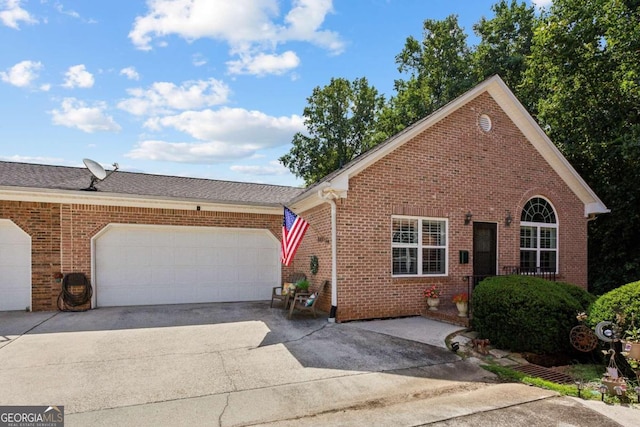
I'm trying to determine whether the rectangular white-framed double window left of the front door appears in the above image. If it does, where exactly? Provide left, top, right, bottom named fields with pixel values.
left=391, top=217, right=448, bottom=276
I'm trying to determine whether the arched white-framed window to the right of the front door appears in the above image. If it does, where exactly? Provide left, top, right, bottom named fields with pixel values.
left=520, top=197, right=558, bottom=273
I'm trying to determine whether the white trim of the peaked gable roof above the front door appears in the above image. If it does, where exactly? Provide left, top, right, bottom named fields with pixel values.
left=290, top=75, right=610, bottom=216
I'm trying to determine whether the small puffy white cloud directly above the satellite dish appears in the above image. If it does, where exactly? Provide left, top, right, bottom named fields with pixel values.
left=51, top=98, right=121, bottom=133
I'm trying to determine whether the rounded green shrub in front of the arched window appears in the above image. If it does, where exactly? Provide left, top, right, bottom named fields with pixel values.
left=471, top=276, right=593, bottom=354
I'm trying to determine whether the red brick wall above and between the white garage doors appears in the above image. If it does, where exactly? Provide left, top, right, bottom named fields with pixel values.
left=0, top=201, right=284, bottom=311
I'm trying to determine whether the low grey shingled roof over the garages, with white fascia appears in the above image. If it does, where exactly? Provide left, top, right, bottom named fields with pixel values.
left=0, top=161, right=303, bottom=213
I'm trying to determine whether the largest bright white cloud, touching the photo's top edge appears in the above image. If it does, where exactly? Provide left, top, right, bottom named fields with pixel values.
left=129, top=0, right=344, bottom=74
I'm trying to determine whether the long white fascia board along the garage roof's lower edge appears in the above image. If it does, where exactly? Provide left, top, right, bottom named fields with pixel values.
left=0, top=186, right=282, bottom=215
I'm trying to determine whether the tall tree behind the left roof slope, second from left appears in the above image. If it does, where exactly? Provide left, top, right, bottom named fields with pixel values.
left=378, top=15, right=475, bottom=138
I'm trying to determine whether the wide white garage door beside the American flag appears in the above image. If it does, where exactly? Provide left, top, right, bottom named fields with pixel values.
left=94, top=224, right=280, bottom=307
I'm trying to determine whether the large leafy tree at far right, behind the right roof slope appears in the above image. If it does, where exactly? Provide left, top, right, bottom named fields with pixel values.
left=523, top=0, right=640, bottom=293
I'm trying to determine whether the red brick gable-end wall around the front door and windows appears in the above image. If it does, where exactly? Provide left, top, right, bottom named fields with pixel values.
left=324, top=94, right=587, bottom=321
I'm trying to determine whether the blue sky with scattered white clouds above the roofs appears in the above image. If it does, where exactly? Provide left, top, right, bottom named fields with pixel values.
left=0, top=0, right=550, bottom=185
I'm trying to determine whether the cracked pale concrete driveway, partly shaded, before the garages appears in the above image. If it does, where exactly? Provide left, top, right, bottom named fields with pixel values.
left=0, top=302, right=632, bottom=426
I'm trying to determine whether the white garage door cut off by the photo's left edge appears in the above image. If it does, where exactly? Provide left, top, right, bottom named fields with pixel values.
left=0, top=219, right=31, bottom=311
